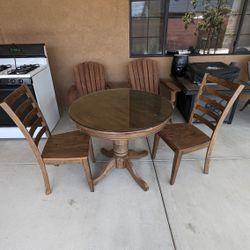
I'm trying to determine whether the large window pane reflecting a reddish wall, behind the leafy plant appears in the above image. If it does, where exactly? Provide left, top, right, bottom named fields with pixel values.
left=166, top=0, right=244, bottom=54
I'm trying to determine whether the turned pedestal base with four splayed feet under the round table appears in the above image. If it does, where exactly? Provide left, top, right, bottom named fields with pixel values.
left=94, top=140, right=148, bottom=191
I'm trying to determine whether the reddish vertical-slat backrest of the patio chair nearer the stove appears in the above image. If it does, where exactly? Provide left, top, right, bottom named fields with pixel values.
left=73, top=62, right=106, bottom=95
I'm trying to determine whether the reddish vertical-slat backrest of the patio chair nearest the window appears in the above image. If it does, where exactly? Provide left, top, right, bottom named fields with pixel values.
left=128, top=59, right=159, bottom=94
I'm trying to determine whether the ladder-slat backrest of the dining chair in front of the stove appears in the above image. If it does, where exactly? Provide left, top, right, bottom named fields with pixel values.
left=0, top=85, right=51, bottom=160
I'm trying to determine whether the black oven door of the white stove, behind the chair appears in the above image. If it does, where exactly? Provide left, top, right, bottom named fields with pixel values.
left=0, top=84, right=35, bottom=127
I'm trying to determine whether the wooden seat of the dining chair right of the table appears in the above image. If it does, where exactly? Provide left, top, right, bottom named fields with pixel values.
left=159, top=123, right=210, bottom=152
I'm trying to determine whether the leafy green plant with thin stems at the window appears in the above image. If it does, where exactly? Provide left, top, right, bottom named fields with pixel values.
left=182, top=0, right=231, bottom=54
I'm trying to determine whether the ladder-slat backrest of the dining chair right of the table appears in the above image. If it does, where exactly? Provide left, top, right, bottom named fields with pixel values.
left=189, top=74, right=244, bottom=137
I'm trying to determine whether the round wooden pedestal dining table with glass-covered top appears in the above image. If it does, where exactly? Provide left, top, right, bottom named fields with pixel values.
left=69, top=88, right=173, bottom=191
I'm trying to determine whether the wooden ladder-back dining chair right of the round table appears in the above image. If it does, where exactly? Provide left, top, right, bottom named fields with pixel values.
left=152, top=74, right=244, bottom=185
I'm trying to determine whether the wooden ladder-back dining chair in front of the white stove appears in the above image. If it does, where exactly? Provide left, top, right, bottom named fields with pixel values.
left=0, top=85, right=94, bottom=194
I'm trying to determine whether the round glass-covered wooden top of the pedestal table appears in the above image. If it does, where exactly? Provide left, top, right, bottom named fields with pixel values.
left=69, top=88, right=173, bottom=139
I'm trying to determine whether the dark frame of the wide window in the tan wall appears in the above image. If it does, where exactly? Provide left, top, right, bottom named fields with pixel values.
left=129, top=0, right=250, bottom=58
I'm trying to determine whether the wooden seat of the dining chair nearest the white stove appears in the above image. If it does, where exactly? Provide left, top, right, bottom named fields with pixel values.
left=42, top=131, right=90, bottom=164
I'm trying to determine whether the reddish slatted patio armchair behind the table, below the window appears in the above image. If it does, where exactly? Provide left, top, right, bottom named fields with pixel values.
left=128, top=59, right=180, bottom=105
